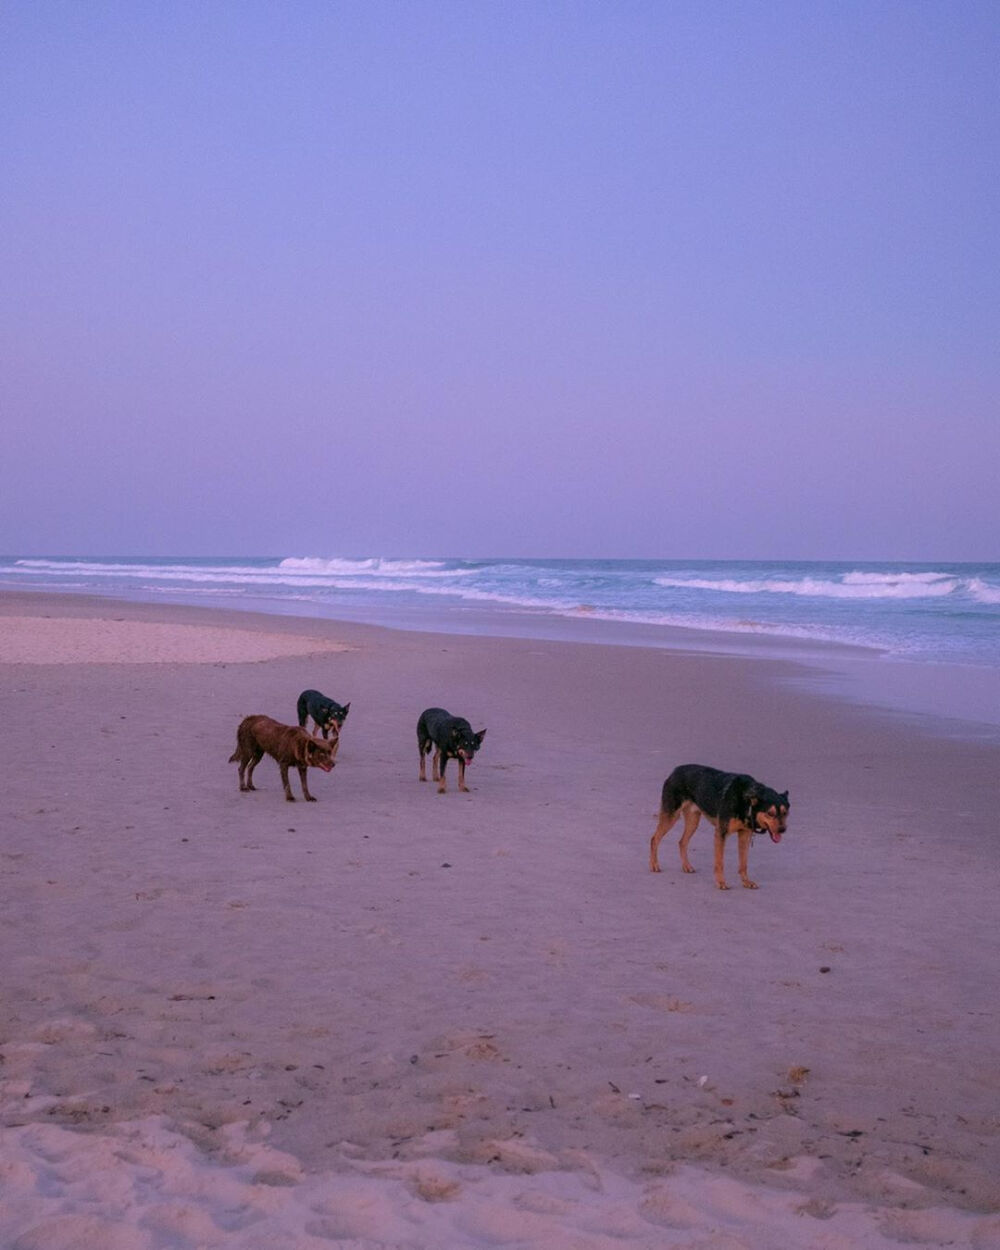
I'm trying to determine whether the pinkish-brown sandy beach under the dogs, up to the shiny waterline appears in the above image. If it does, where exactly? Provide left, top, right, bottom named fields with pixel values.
left=0, top=594, right=1000, bottom=1250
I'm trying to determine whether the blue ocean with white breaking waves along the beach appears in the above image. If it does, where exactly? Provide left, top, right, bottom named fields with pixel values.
left=0, top=556, right=1000, bottom=669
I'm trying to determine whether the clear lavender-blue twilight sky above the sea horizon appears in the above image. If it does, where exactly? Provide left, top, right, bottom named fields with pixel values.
left=0, top=0, right=1000, bottom=560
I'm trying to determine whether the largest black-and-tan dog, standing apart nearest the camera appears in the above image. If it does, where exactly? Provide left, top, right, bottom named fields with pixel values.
left=649, top=764, right=789, bottom=890
